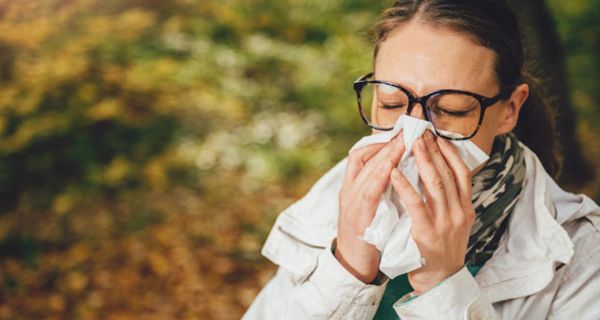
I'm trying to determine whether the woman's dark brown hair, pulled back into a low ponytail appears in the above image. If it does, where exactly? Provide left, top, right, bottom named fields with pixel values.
left=374, top=0, right=561, bottom=177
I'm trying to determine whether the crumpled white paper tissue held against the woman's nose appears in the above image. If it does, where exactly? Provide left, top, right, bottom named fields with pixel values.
left=350, top=115, right=489, bottom=279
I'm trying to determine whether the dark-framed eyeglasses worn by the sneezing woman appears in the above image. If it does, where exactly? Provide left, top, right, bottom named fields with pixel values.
left=354, top=73, right=514, bottom=140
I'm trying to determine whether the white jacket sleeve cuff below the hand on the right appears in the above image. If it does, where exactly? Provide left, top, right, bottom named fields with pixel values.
left=394, top=267, right=500, bottom=320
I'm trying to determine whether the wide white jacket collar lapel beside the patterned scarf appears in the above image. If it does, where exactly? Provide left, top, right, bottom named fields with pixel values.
left=476, top=144, right=589, bottom=303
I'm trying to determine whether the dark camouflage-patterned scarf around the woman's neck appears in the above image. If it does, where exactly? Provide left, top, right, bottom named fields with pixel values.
left=465, top=133, right=525, bottom=266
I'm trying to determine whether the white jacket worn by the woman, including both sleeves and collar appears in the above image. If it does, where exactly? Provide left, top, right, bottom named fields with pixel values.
left=243, top=147, right=600, bottom=320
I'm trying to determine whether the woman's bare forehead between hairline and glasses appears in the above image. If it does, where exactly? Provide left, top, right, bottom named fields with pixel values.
left=374, top=20, right=498, bottom=95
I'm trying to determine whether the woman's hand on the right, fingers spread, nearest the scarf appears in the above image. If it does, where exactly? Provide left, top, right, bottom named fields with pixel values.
left=392, top=130, right=475, bottom=294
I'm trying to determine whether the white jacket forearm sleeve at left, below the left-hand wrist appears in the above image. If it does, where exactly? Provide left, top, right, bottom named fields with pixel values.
left=243, top=239, right=385, bottom=319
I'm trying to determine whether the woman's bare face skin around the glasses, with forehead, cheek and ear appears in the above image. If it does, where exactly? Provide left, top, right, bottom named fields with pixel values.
left=374, top=19, right=528, bottom=159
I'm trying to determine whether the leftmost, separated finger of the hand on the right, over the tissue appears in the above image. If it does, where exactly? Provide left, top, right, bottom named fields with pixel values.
left=392, top=168, right=432, bottom=232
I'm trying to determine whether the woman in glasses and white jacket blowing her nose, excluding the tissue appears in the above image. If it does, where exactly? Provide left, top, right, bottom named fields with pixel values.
left=244, top=0, right=600, bottom=319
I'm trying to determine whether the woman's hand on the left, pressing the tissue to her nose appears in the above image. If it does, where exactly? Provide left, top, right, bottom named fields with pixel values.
left=335, top=134, right=405, bottom=283
